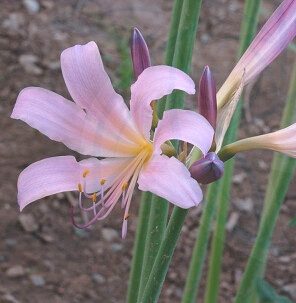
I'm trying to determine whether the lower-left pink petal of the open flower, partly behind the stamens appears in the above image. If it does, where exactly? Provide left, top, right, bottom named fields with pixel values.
left=17, top=156, right=130, bottom=211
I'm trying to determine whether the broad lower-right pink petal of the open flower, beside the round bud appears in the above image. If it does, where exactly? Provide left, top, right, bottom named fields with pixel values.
left=138, top=156, right=203, bottom=208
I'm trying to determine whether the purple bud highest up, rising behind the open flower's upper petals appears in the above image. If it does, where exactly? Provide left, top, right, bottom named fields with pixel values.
left=131, top=27, right=151, bottom=80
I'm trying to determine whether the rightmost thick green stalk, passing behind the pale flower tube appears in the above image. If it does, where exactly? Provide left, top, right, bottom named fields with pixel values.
left=236, top=63, right=296, bottom=303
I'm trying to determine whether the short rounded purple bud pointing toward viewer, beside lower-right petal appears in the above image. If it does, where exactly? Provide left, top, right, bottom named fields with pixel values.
left=189, top=152, right=224, bottom=184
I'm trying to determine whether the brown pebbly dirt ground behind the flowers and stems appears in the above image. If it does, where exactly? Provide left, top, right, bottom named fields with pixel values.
left=0, top=0, right=296, bottom=303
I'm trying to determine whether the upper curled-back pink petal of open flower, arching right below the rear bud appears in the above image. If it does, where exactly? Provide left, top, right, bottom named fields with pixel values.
left=130, top=65, right=195, bottom=139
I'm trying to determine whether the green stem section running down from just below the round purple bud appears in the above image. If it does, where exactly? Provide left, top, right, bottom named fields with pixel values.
left=182, top=181, right=221, bottom=303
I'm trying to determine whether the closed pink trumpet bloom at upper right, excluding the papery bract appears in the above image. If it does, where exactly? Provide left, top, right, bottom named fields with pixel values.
left=217, top=0, right=296, bottom=108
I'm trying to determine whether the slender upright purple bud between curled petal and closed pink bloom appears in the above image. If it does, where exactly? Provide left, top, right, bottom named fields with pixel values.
left=198, top=66, right=217, bottom=129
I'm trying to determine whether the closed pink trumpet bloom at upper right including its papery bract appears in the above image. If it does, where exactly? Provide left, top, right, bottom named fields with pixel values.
left=215, top=0, right=296, bottom=152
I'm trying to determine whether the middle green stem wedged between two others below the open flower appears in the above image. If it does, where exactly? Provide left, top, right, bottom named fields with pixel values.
left=138, top=195, right=169, bottom=302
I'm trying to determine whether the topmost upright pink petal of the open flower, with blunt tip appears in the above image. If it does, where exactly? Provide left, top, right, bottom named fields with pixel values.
left=61, top=41, right=142, bottom=144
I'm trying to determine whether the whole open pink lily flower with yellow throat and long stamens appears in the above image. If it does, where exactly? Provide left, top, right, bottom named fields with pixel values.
left=11, top=42, right=214, bottom=237
